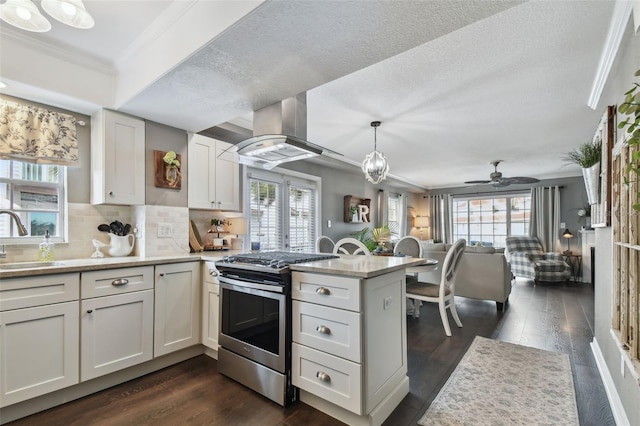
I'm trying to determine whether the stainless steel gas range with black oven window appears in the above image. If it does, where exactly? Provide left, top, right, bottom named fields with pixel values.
left=215, top=251, right=338, bottom=406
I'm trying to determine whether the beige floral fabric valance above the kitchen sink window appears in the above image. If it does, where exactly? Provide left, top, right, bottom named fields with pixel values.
left=0, top=100, right=78, bottom=166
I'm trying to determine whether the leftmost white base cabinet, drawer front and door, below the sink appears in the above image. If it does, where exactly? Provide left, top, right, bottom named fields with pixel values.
left=0, top=273, right=79, bottom=407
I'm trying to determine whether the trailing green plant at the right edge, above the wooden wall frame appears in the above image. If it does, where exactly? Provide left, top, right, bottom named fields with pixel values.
left=618, top=70, right=640, bottom=211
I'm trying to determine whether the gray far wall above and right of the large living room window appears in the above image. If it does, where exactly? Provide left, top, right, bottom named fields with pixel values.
left=429, top=176, right=587, bottom=253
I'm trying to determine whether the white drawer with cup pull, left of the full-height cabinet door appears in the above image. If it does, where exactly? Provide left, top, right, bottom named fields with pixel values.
left=81, top=266, right=153, bottom=299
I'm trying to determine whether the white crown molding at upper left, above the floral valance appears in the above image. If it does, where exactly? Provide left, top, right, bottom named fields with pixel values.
left=0, top=26, right=115, bottom=75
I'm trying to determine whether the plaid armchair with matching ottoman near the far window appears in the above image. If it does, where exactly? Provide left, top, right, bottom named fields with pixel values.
left=506, top=236, right=571, bottom=284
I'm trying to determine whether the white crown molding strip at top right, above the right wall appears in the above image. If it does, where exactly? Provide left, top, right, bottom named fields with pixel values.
left=587, top=1, right=633, bottom=110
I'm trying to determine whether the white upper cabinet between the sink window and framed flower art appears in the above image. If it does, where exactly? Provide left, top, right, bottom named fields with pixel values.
left=91, top=109, right=145, bottom=205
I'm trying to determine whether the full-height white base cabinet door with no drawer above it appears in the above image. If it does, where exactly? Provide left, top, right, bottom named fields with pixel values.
left=153, top=262, right=202, bottom=357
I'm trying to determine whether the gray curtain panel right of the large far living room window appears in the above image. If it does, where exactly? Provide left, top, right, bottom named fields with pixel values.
left=529, top=186, right=560, bottom=252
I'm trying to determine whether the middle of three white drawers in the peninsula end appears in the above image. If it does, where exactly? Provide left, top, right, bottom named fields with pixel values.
left=293, top=300, right=361, bottom=362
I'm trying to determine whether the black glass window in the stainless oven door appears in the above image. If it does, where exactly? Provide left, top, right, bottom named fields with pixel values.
left=220, top=287, right=284, bottom=355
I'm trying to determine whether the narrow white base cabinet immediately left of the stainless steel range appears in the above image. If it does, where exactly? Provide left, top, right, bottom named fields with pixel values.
left=202, top=261, right=220, bottom=351
